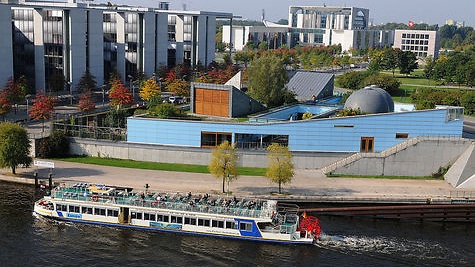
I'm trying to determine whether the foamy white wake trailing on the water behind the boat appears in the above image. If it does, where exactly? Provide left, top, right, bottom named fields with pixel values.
left=315, top=233, right=460, bottom=262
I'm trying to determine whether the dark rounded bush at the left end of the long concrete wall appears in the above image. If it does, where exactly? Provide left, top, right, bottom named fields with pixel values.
left=38, top=131, right=69, bottom=158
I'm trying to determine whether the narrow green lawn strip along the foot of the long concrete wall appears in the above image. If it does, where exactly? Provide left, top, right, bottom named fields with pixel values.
left=57, top=157, right=266, bottom=176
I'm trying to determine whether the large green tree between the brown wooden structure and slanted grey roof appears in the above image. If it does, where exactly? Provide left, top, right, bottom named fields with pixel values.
left=248, top=55, right=288, bottom=107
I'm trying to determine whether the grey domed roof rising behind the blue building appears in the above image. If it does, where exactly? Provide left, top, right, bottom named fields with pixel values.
left=345, top=85, right=394, bottom=114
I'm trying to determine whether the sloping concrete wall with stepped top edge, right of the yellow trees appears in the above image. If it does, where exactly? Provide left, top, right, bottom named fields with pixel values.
left=332, top=139, right=471, bottom=176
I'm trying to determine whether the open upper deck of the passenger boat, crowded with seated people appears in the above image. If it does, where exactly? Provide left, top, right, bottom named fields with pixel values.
left=51, top=184, right=275, bottom=218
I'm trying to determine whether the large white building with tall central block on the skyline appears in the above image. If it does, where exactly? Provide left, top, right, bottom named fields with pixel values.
left=223, top=6, right=394, bottom=51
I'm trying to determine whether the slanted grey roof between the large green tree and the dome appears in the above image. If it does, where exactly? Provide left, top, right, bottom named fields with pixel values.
left=287, top=71, right=333, bottom=100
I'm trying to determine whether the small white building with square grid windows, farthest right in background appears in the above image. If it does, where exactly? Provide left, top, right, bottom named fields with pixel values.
left=393, top=30, right=440, bottom=58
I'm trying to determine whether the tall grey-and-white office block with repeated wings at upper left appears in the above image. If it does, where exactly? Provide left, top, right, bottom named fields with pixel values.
left=0, top=1, right=232, bottom=92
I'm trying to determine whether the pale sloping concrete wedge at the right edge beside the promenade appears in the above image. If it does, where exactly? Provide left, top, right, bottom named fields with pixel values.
left=445, top=142, right=475, bottom=189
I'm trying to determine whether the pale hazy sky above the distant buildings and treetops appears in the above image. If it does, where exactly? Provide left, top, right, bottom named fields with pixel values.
left=109, top=0, right=475, bottom=27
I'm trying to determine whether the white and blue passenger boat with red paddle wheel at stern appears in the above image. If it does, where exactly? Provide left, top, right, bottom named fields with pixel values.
left=34, top=183, right=320, bottom=244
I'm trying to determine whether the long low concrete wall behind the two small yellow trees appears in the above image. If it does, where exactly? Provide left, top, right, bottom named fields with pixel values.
left=70, top=138, right=350, bottom=169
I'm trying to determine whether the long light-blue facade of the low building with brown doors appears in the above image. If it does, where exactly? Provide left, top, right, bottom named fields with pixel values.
left=127, top=107, right=463, bottom=152
